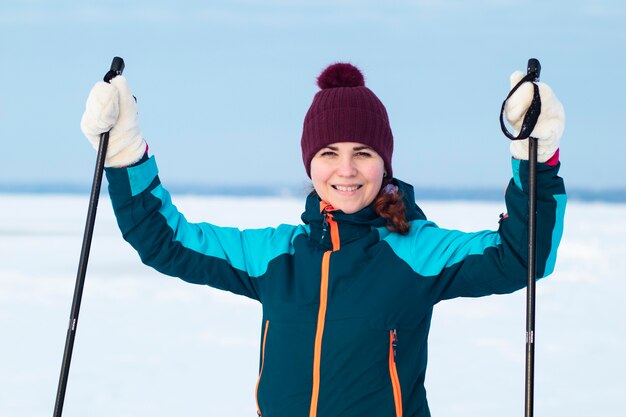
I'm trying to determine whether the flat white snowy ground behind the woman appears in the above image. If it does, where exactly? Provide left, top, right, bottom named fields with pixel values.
left=0, top=195, right=626, bottom=417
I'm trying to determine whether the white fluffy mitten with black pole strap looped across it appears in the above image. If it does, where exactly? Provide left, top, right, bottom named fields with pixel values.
left=504, top=71, right=565, bottom=162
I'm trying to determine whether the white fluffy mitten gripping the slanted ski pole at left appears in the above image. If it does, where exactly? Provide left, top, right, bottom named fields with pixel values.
left=80, top=75, right=146, bottom=168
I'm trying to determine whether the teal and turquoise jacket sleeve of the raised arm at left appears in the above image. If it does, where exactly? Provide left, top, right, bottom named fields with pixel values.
left=106, top=157, right=302, bottom=300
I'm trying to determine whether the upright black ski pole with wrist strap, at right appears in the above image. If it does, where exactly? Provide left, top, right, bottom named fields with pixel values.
left=500, top=58, right=541, bottom=417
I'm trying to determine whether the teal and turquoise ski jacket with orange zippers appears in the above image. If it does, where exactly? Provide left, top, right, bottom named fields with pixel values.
left=106, top=157, right=566, bottom=417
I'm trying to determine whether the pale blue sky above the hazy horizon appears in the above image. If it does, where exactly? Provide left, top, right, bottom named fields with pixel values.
left=0, top=0, right=626, bottom=189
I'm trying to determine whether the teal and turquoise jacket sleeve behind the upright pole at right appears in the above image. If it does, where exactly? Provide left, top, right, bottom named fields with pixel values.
left=382, top=159, right=567, bottom=303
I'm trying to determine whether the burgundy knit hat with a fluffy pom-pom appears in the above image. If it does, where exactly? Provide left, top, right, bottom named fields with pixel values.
left=301, top=63, right=393, bottom=177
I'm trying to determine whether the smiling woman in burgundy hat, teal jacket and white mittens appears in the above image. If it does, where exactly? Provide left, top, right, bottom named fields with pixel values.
left=81, top=64, right=565, bottom=417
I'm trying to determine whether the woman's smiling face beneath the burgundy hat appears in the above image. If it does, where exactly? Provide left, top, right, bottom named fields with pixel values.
left=311, top=142, right=385, bottom=214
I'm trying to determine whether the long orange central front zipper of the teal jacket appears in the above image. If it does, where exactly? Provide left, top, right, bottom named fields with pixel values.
left=309, top=204, right=340, bottom=417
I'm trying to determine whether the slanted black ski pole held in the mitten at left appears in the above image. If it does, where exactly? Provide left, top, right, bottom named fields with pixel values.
left=53, top=57, right=124, bottom=417
